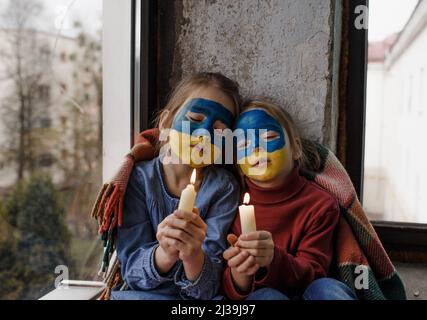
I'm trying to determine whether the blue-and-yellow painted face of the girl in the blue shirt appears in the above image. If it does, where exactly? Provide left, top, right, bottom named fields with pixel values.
left=169, top=98, right=234, bottom=168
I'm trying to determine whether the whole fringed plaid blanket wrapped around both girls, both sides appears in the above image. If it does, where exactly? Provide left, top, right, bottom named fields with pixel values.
left=92, top=129, right=406, bottom=300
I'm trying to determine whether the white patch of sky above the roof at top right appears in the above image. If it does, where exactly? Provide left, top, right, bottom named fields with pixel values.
left=368, top=0, right=420, bottom=41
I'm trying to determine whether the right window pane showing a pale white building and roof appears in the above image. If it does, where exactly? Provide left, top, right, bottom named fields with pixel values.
left=363, top=0, right=427, bottom=223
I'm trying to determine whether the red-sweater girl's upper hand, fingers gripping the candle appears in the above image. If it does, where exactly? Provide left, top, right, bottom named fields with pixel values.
left=236, top=231, right=274, bottom=267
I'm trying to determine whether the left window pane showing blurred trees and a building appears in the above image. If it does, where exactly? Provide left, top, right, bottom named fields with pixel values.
left=0, top=0, right=102, bottom=299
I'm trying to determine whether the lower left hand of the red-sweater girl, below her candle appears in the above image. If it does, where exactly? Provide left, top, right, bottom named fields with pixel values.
left=223, top=234, right=259, bottom=276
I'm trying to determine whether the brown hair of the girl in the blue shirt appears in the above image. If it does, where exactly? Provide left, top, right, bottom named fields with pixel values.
left=154, top=72, right=242, bottom=128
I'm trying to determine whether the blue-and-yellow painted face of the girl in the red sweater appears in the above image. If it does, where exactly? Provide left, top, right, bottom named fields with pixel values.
left=236, top=109, right=289, bottom=181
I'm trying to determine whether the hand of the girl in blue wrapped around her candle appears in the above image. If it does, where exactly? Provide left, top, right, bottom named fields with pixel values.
left=164, top=208, right=207, bottom=262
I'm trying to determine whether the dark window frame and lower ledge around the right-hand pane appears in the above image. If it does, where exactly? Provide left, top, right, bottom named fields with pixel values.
left=344, top=0, right=427, bottom=256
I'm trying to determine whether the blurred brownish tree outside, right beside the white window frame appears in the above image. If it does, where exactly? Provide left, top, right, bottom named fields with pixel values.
left=52, top=21, right=102, bottom=238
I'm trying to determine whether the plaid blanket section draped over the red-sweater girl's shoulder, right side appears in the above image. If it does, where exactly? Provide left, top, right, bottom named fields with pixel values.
left=301, top=144, right=406, bottom=300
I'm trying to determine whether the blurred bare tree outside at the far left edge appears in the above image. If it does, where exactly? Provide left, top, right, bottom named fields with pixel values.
left=0, top=0, right=49, bottom=181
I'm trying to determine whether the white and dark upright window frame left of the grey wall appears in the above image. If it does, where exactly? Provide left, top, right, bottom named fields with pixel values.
left=102, top=0, right=157, bottom=176
